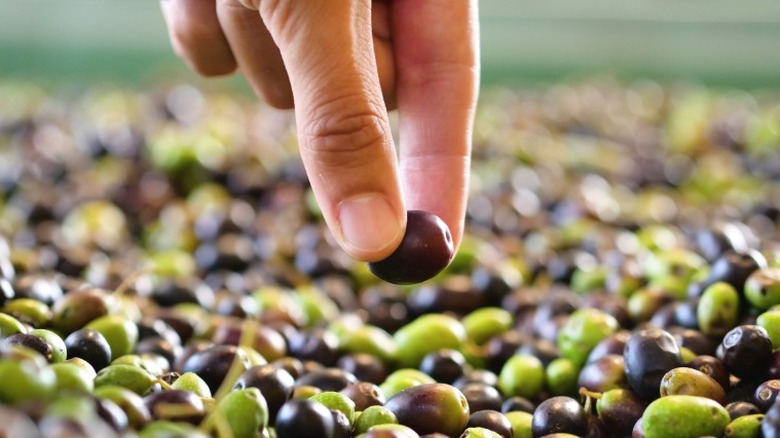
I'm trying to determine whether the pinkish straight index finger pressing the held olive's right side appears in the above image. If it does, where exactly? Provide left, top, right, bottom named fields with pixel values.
left=391, top=0, right=479, bottom=248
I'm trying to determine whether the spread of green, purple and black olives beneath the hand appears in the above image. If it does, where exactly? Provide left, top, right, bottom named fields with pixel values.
left=0, top=78, right=780, bottom=438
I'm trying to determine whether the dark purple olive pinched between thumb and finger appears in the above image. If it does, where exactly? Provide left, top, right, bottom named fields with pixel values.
left=368, top=210, right=454, bottom=284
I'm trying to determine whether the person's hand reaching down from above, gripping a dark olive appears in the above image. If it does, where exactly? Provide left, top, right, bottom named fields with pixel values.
left=161, top=0, right=479, bottom=262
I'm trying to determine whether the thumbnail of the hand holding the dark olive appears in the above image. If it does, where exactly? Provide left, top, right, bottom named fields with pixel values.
left=338, top=193, right=401, bottom=253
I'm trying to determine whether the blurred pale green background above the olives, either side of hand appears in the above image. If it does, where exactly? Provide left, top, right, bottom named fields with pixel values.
left=0, top=0, right=780, bottom=88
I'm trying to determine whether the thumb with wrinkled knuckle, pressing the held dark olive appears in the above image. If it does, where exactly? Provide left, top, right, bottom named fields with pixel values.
left=259, top=0, right=406, bottom=261
